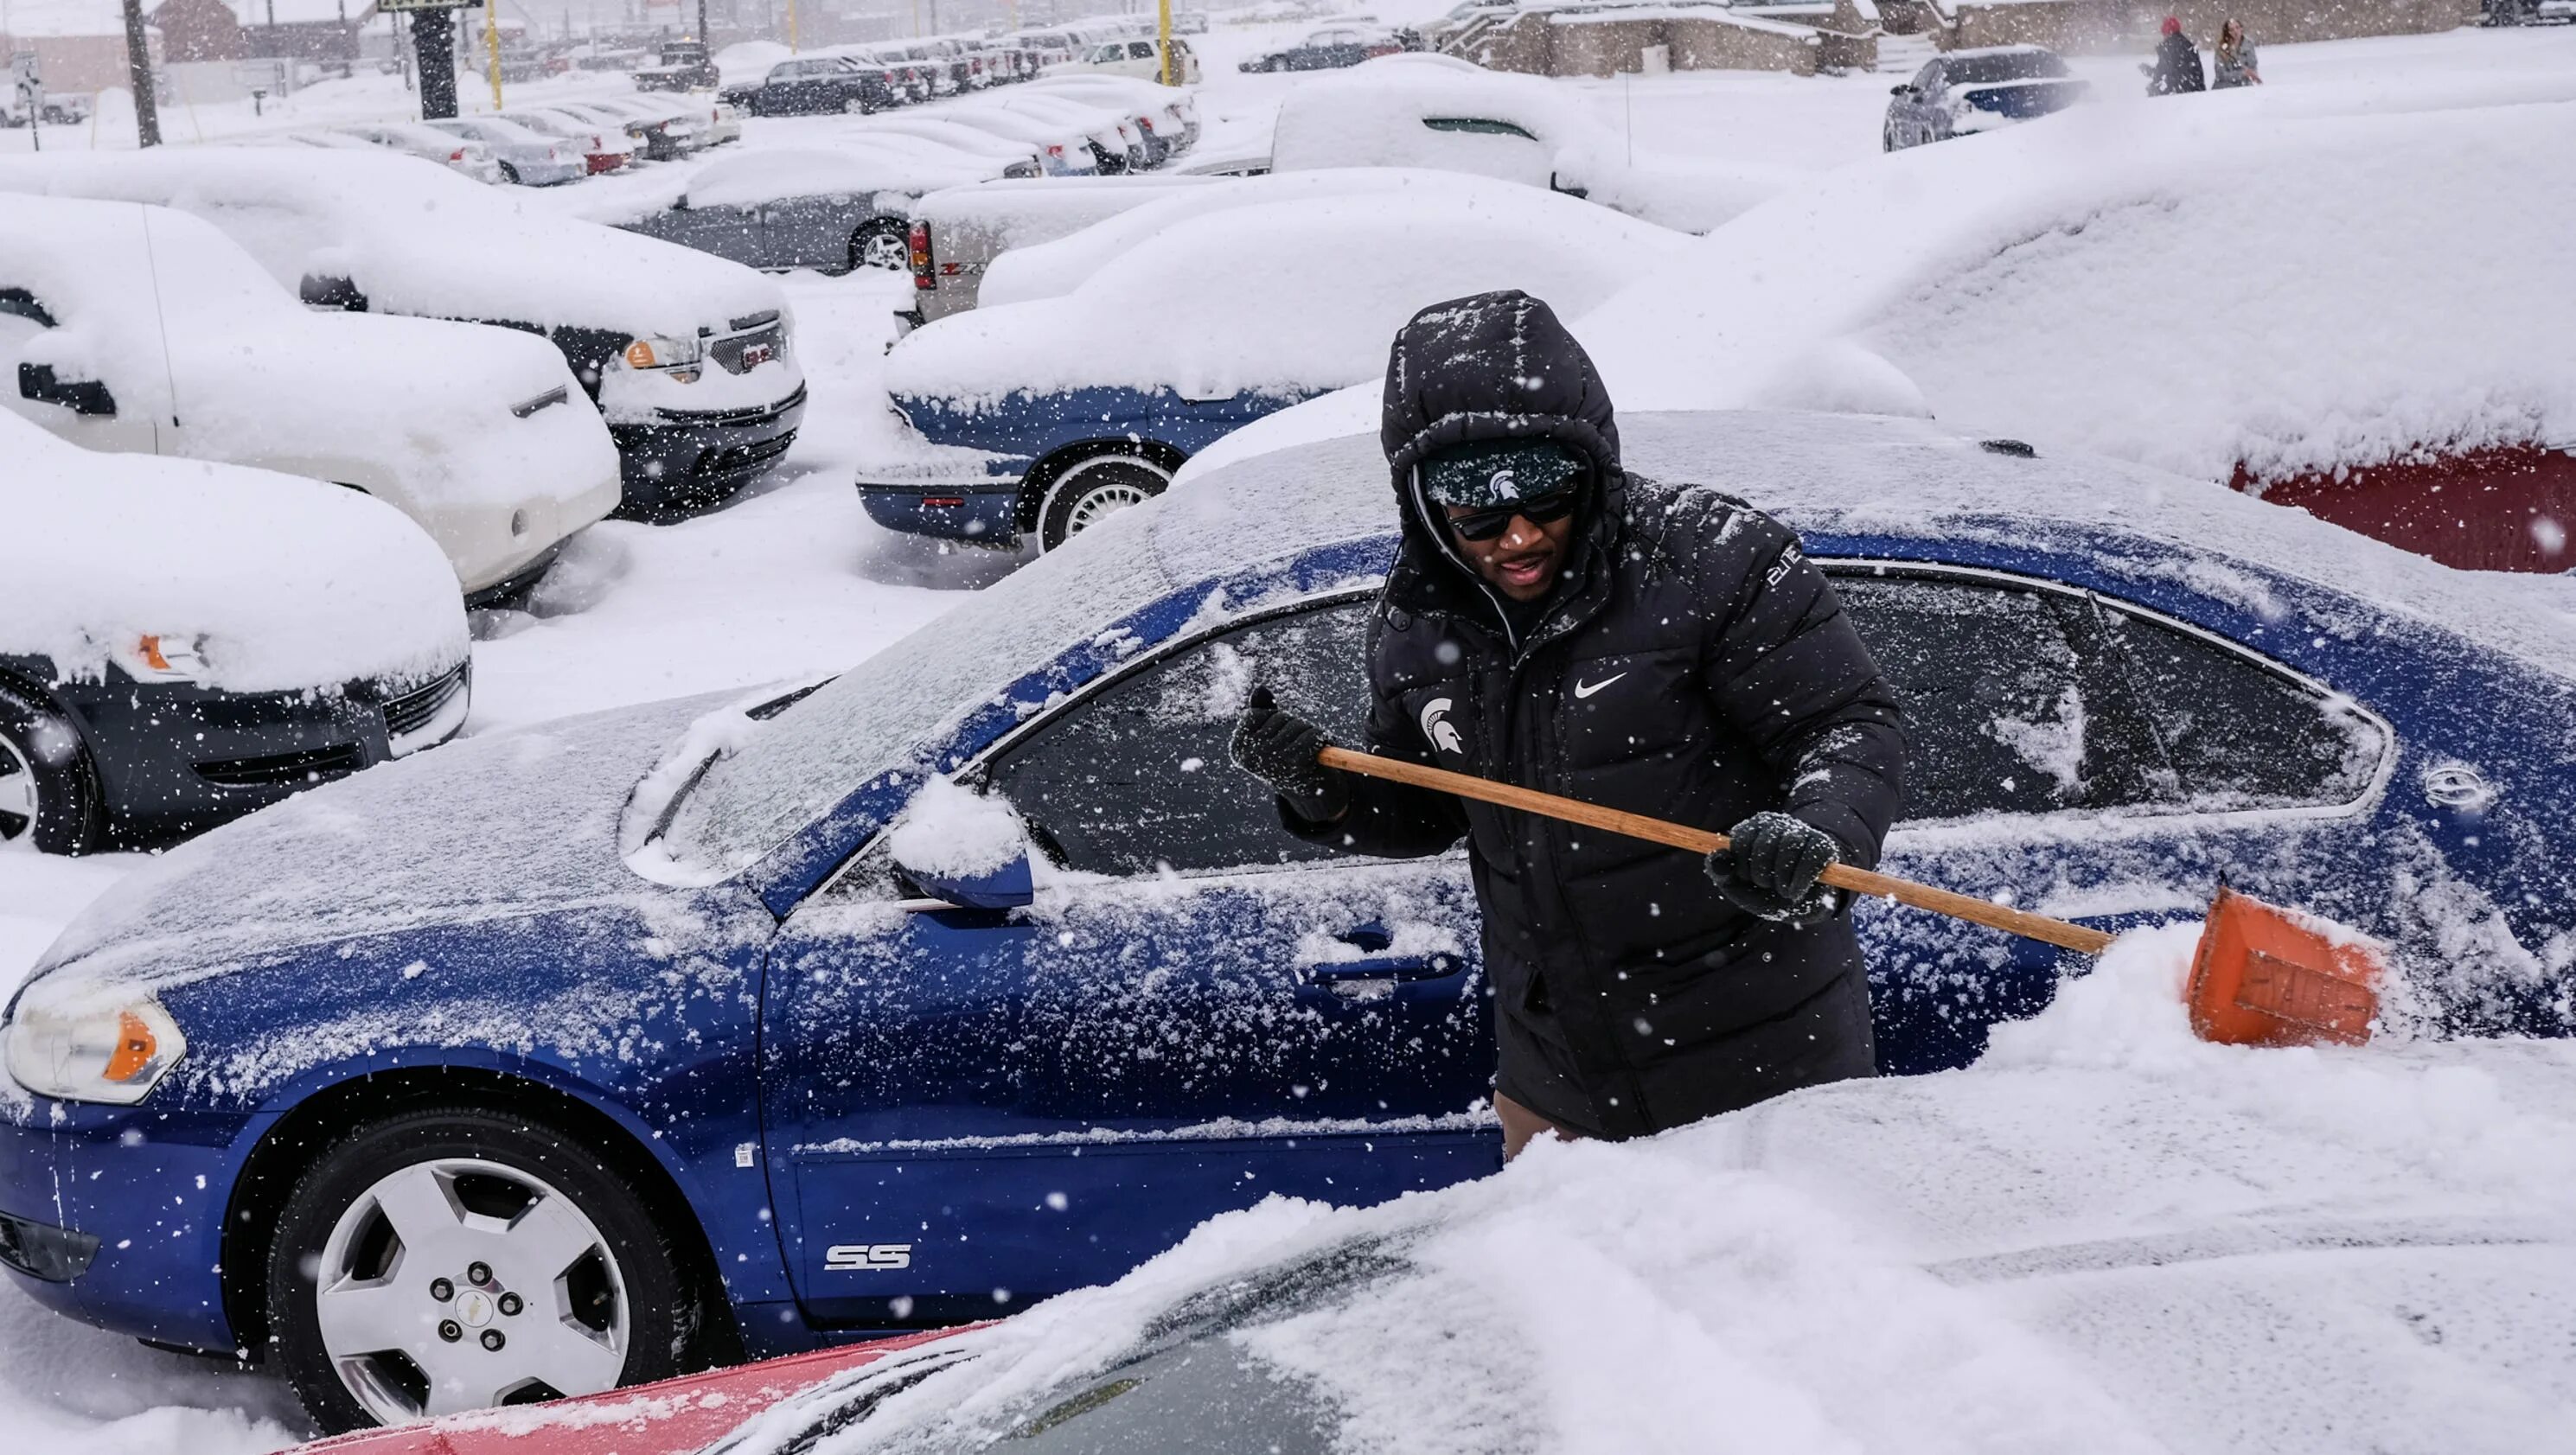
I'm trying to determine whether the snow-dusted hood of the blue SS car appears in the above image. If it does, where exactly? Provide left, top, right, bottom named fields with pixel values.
left=26, top=692, right=729, bottom=1010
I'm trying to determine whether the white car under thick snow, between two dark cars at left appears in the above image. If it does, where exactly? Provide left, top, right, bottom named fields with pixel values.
left=0, top=196, right=618, bottom=600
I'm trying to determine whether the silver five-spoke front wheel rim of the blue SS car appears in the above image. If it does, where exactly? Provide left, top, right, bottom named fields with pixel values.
left=314, top=1156, right=631, bottom=1424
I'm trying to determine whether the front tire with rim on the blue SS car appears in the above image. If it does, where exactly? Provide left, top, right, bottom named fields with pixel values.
left=265, top=1105, right=700, bottom=1432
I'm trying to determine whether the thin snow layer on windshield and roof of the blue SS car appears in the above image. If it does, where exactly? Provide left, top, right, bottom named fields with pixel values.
left=668, top=412, right=2576, bottom=881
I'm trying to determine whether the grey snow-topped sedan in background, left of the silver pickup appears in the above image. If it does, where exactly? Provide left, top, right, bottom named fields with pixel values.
left=618, top=134, right=1039, bottom=273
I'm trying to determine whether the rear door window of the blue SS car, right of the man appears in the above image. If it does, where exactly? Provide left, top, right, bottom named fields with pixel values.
left=1834, top=574, right=2156, bottom=819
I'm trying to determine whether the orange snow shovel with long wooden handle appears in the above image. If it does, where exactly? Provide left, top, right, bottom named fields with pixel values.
left=1319, top=747, right=2388, bottom=1045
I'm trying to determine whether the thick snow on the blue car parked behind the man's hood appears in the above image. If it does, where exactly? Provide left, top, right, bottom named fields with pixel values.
left=886, top=170, right=1687, bottom=407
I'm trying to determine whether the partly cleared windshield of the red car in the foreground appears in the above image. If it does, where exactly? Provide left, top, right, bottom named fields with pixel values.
left=703, top=1236, right=1411, bottom=1455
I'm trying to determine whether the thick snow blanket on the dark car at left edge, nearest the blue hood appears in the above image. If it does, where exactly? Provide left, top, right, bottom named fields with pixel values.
left=0, top=412, right=466, bottom=692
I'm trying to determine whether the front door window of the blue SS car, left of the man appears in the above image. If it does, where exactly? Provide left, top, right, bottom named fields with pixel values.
left=989, top=597, right=1373, bottom=873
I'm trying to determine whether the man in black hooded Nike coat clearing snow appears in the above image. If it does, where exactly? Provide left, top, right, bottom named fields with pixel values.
left=1234, top=291, right=1906, bottom=1153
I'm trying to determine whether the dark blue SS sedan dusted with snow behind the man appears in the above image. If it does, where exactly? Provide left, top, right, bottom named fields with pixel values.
left=0, top=415, right=2576, bottom=1426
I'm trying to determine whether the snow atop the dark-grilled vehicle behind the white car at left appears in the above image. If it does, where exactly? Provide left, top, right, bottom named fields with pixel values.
left=0, top=147, right=786, bottom=335
